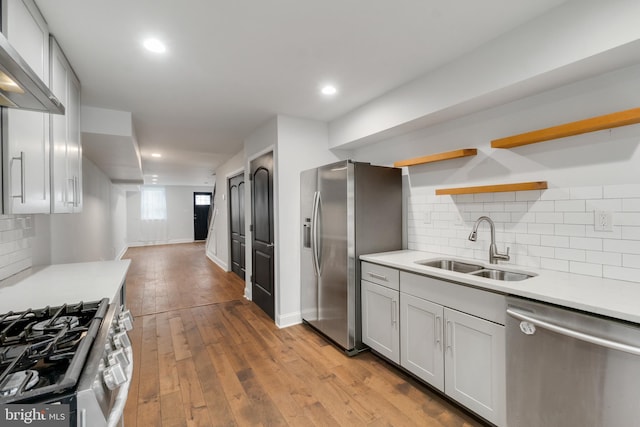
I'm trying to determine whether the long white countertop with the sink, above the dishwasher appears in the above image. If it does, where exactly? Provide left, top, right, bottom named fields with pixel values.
left=362, top=250, right=640, bottom=323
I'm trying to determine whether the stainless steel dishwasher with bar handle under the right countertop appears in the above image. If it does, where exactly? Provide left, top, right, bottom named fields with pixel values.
left=506, top=297, right=640, bottom=427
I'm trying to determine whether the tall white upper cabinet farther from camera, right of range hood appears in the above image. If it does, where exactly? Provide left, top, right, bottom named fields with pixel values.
left=50, top=37, right=82, bottom=213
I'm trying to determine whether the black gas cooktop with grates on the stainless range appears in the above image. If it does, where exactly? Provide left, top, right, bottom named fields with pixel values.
left=0, top=298, right=109, bottom=404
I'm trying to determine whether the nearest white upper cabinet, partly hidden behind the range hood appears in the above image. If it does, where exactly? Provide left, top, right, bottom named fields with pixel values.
left=2, top=0, right=51, bottom=214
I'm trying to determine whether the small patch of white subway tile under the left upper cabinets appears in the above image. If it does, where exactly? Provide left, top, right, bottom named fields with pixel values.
left=0, top=215, right=34, bottom=280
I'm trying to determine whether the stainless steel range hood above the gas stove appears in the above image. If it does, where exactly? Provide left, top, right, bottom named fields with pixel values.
left=0, top=33, right=64, bottom=114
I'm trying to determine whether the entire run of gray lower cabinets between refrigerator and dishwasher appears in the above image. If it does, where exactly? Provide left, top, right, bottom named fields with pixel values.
left=362, top=263, right=506, bottom=426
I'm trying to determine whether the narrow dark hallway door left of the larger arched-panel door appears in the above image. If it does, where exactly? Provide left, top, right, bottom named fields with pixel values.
left=229, top=172, right=245, bottom=280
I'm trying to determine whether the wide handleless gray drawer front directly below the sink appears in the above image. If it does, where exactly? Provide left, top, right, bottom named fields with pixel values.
left=400, top=271, right=506, bottom=325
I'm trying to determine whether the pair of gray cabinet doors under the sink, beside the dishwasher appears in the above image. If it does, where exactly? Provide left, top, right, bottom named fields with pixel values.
left=400, top=285, right=506, bottom=425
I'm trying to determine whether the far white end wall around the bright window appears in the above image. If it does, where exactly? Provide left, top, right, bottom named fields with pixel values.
left=126, top=185, right=213, bottom=246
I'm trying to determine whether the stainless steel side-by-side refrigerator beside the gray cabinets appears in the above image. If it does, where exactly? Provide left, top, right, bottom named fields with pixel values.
left=300, top=160, right=402, bottom=355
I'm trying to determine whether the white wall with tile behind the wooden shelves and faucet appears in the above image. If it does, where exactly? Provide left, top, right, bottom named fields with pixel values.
left=355, top=65, right=640, bottom=282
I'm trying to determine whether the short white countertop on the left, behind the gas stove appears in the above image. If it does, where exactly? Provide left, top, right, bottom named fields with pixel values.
left=0, top=260, right=131, bottom=313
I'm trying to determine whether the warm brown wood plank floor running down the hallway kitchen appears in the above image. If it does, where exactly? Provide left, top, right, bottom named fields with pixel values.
left=125, top=243, right=481, bottom=427
